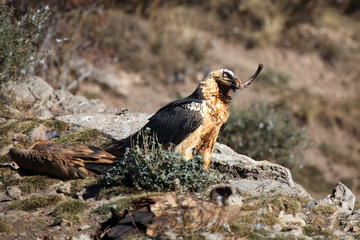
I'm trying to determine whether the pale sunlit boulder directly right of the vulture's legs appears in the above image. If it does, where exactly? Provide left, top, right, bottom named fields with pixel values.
left=212, top=143, right=311, bottom=198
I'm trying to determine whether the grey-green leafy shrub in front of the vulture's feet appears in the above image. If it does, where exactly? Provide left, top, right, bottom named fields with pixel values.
left=103, top=133, right=220, bottom=191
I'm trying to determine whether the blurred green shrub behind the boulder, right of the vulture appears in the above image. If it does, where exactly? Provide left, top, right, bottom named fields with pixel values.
left=220, top=103, right=305, bottom=168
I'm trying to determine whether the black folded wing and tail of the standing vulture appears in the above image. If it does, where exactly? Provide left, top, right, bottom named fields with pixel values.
left=105, top=97, right=203, bottom=156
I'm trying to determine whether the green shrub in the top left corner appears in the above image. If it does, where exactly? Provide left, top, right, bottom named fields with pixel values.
left=0, top=4, right=49, bottom=84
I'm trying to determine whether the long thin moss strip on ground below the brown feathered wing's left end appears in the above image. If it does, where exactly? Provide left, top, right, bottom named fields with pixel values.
left=9, top=195, right=62, bottom=212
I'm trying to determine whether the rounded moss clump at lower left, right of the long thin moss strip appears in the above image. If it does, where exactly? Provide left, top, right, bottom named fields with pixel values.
left=51, top=200, right=89, bottom=225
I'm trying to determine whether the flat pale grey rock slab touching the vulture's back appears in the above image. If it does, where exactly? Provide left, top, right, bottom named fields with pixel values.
left=56, top=111, right=152, bottom=139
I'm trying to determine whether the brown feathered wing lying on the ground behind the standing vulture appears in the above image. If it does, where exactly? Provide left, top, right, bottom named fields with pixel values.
left=9, top=144, right=115, bottom=179
